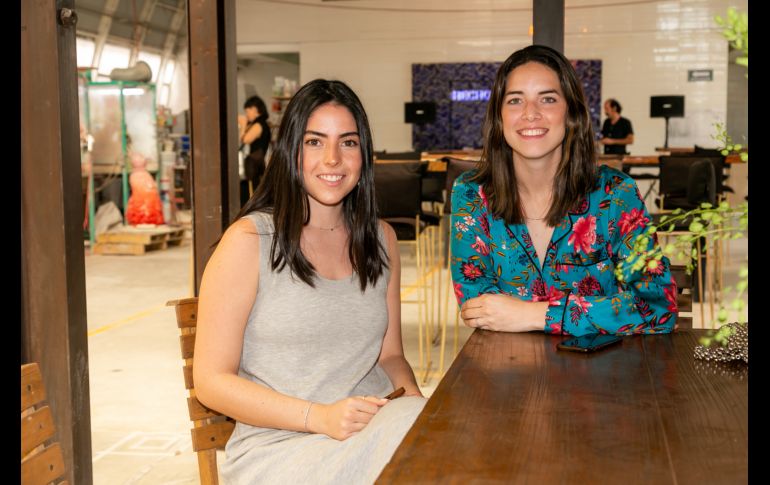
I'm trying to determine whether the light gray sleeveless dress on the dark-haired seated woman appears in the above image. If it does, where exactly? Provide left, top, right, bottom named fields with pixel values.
left=220, top=212, right=426, bottom=485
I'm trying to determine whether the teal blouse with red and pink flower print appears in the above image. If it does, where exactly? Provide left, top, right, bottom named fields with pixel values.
left=451, top=166, right=677, bottom=336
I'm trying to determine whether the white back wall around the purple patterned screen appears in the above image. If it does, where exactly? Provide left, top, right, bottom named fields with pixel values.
left=236, top=0, right=748, bottom=155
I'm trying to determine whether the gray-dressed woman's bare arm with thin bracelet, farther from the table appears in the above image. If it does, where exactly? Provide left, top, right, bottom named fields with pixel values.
left=193, top=219, right=386, bottom=439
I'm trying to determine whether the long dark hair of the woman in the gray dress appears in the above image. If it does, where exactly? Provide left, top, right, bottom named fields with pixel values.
left=231, top=79, right=388, bottom=292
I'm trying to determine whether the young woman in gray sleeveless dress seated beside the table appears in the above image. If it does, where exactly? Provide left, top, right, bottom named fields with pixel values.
left=194, top=79, right=425, bottom=484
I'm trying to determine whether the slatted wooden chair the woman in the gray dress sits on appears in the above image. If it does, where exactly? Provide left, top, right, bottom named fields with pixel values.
left=166, top=298, right=235, bottom=485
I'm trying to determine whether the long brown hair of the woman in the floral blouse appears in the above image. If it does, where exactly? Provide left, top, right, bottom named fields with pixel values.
left=473, top=45, right=596, bottom=227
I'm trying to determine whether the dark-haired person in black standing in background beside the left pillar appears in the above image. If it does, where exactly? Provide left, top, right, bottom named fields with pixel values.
left=238, top=96, right=270, bottom=200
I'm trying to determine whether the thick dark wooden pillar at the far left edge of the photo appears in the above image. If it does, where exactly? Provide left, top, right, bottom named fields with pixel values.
left=21, top=0, right=93, bottom=485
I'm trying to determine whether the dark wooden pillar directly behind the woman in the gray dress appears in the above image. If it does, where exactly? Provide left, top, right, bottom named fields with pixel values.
left=187, top=0, right=240, bottom=295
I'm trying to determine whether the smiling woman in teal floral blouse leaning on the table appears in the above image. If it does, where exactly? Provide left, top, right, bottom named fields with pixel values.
left=451, top=45, right=677, bottom=335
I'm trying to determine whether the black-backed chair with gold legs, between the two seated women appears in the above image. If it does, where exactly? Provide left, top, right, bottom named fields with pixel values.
left=374, top=161, right=434, bottom=383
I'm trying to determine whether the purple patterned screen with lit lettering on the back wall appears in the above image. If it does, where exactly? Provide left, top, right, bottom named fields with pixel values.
left=412, top=60, right=602, bottom=151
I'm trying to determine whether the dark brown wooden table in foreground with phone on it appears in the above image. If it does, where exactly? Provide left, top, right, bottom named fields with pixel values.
left=377, top=330, right=748, bottom=485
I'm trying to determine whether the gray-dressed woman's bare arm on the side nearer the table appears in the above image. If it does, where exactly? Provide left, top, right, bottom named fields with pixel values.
left=379, top=221, right=422, bottom=396
